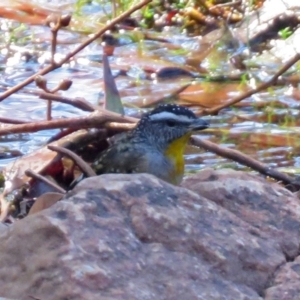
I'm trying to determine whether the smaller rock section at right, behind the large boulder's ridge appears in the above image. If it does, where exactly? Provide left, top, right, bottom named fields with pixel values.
left=182, top=169, right=300, bottom=259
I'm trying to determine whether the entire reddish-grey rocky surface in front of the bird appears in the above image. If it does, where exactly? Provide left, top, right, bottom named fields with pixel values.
left=0, top=170, right=300, bottom=300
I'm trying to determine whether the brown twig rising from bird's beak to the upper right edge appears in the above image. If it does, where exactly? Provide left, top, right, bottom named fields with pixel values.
left=203, top=53, right=300, bottom=115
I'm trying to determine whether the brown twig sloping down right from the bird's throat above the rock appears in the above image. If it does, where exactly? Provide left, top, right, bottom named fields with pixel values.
left=191, top=137, right=300, bottom=189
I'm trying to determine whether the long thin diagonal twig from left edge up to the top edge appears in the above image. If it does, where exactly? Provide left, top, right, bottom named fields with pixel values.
left=0, top=0, right=152, bottom=101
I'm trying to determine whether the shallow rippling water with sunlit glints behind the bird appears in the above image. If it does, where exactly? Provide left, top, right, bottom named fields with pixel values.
left=0, top=1, right=300, bottom=178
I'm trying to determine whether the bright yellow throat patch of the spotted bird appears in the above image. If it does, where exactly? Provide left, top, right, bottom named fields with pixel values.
left=165, top=133, right=191, bottom=184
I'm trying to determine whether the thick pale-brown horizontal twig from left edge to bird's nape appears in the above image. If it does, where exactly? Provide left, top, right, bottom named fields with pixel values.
left=0, top=109, right=137, bottom=136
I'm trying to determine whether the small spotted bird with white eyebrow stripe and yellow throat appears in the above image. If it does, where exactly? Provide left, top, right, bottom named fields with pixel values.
left=91, top=104, right=209, bottom=185
